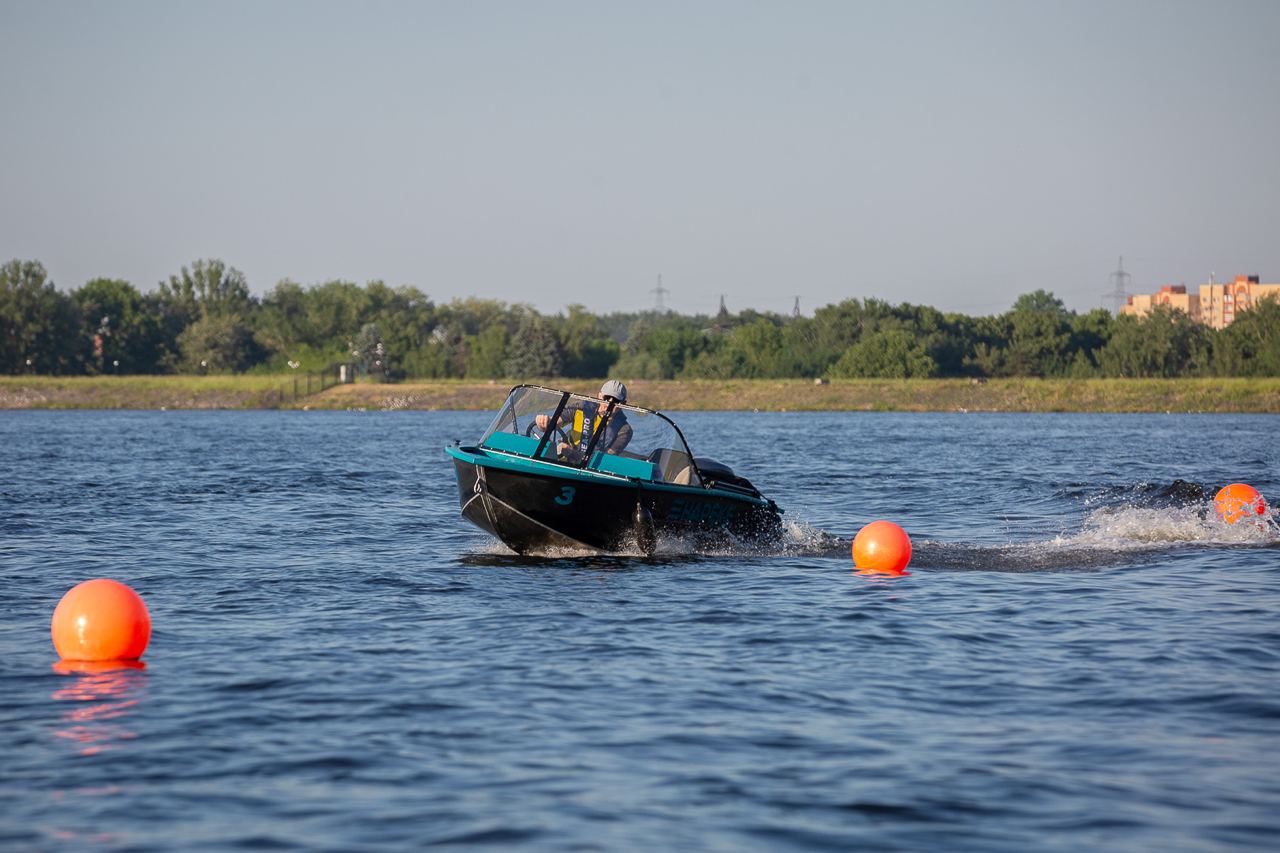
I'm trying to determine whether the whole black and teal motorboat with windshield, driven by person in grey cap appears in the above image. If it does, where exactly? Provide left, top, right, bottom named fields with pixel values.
left=444, top=384, right=782, bottom=555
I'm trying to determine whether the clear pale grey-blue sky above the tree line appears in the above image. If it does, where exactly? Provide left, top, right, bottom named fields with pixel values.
left=0, top=0, right=1280, bottom=314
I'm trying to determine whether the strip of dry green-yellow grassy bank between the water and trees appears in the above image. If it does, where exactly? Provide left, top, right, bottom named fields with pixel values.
left=0, top=375, right=1280, bottom=412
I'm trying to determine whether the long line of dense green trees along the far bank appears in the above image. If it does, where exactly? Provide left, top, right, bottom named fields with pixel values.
left=0, top=260, right=1280, bottom=379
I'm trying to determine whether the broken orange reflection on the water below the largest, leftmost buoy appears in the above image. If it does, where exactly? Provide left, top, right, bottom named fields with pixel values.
left=52, top=661, right=147, bottom=756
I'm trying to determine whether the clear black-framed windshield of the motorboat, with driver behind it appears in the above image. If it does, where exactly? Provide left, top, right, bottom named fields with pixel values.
left=480, top=386, right=701, bottom=485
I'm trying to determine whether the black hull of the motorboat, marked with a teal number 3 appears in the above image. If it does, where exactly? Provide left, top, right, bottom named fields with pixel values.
left=453, top=457, right=782, bottom=553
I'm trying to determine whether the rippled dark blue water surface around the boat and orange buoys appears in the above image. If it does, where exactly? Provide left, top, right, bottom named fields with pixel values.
left=0, top=412, right=1280, bottom=850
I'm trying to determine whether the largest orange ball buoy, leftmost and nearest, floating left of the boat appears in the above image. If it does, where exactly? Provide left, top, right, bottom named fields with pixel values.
left=50, top=578, right=151, bottom=661
